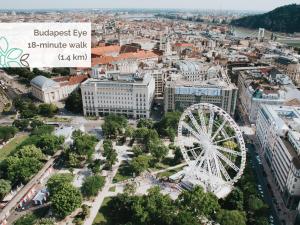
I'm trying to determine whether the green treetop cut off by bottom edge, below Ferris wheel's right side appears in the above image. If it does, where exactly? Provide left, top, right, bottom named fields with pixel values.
left=216, top=209, right=246, bottom=225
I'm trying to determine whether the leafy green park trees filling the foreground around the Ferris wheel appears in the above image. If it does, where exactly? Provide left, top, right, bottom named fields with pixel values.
left=0, top=110, right=269, bottom=225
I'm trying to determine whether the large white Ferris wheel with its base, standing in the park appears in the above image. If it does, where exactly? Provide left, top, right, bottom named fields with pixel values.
left=178, top=103, right=246, bottom=197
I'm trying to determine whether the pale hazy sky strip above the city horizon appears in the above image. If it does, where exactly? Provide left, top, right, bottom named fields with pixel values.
left=0, top=0, right=300, bottom=11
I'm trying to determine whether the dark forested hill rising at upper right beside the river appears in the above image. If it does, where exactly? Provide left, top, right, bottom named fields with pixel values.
left=231, top=4, right=300, bottom=33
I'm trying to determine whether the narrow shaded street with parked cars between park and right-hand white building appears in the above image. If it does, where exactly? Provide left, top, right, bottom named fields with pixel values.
left=246, top=144, right=281, bottom=225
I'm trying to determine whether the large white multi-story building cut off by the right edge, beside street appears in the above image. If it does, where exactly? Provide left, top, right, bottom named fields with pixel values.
left=256, top=105, right=300, bottom=209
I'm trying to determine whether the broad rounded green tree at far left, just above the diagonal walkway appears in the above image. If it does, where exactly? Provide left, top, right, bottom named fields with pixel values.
left=5, top=156, right=42, bottom=184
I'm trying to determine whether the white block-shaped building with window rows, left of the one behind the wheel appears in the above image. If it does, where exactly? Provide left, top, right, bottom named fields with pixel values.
left=81, top=72, right=155, bottom=118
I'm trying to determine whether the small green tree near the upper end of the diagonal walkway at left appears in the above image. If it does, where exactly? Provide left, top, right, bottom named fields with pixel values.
left=36, top=134, right=64, bottom=155
